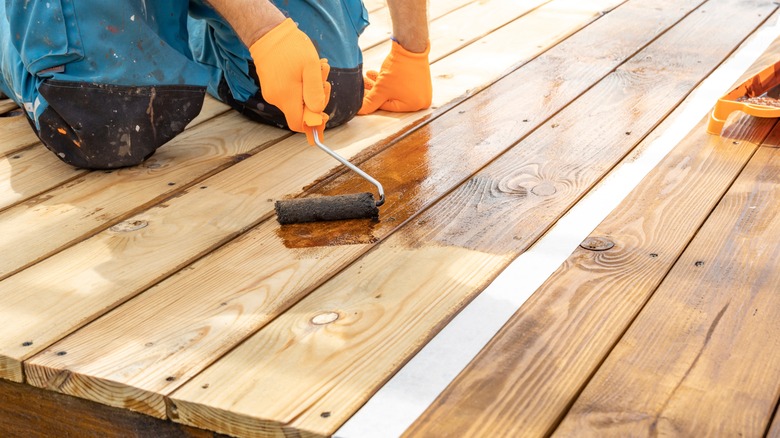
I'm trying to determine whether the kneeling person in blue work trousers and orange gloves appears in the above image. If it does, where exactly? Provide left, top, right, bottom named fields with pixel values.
left=0, top=0, right=432, bottom=169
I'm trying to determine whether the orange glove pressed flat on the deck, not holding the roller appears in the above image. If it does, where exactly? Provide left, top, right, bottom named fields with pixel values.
left=358, top=41, right=433, bottom=114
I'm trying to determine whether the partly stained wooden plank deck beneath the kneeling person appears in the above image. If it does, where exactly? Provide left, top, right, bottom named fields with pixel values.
left=0, top=0, right=780, bottom=438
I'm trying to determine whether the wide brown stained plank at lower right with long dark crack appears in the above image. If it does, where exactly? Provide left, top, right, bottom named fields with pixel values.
left=555, top=142, right=780, bottom=436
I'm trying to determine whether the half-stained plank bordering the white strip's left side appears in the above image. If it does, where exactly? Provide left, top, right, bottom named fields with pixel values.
left=170, top=2, right=774, bottom=434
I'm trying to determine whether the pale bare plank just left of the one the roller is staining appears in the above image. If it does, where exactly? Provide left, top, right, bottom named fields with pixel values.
left=6, top=1, right=609, bottom=386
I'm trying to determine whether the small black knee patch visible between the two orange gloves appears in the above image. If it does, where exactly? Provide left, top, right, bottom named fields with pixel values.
left=325, top=66, right=363, bottom=128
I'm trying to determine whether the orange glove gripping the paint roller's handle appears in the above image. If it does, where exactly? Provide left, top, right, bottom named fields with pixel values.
left=249, top=18, right=330, bottom=144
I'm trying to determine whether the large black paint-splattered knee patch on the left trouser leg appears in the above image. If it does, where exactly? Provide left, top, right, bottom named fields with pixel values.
left=38, top=81, right=205, bottom=169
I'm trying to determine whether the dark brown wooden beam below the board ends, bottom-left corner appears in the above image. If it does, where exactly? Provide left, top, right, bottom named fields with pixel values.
left=0, top=379, right=224, bottom=438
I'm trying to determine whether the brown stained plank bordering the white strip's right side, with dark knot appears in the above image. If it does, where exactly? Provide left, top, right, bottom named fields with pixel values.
left=407, top=26, right=780, bottom=436
